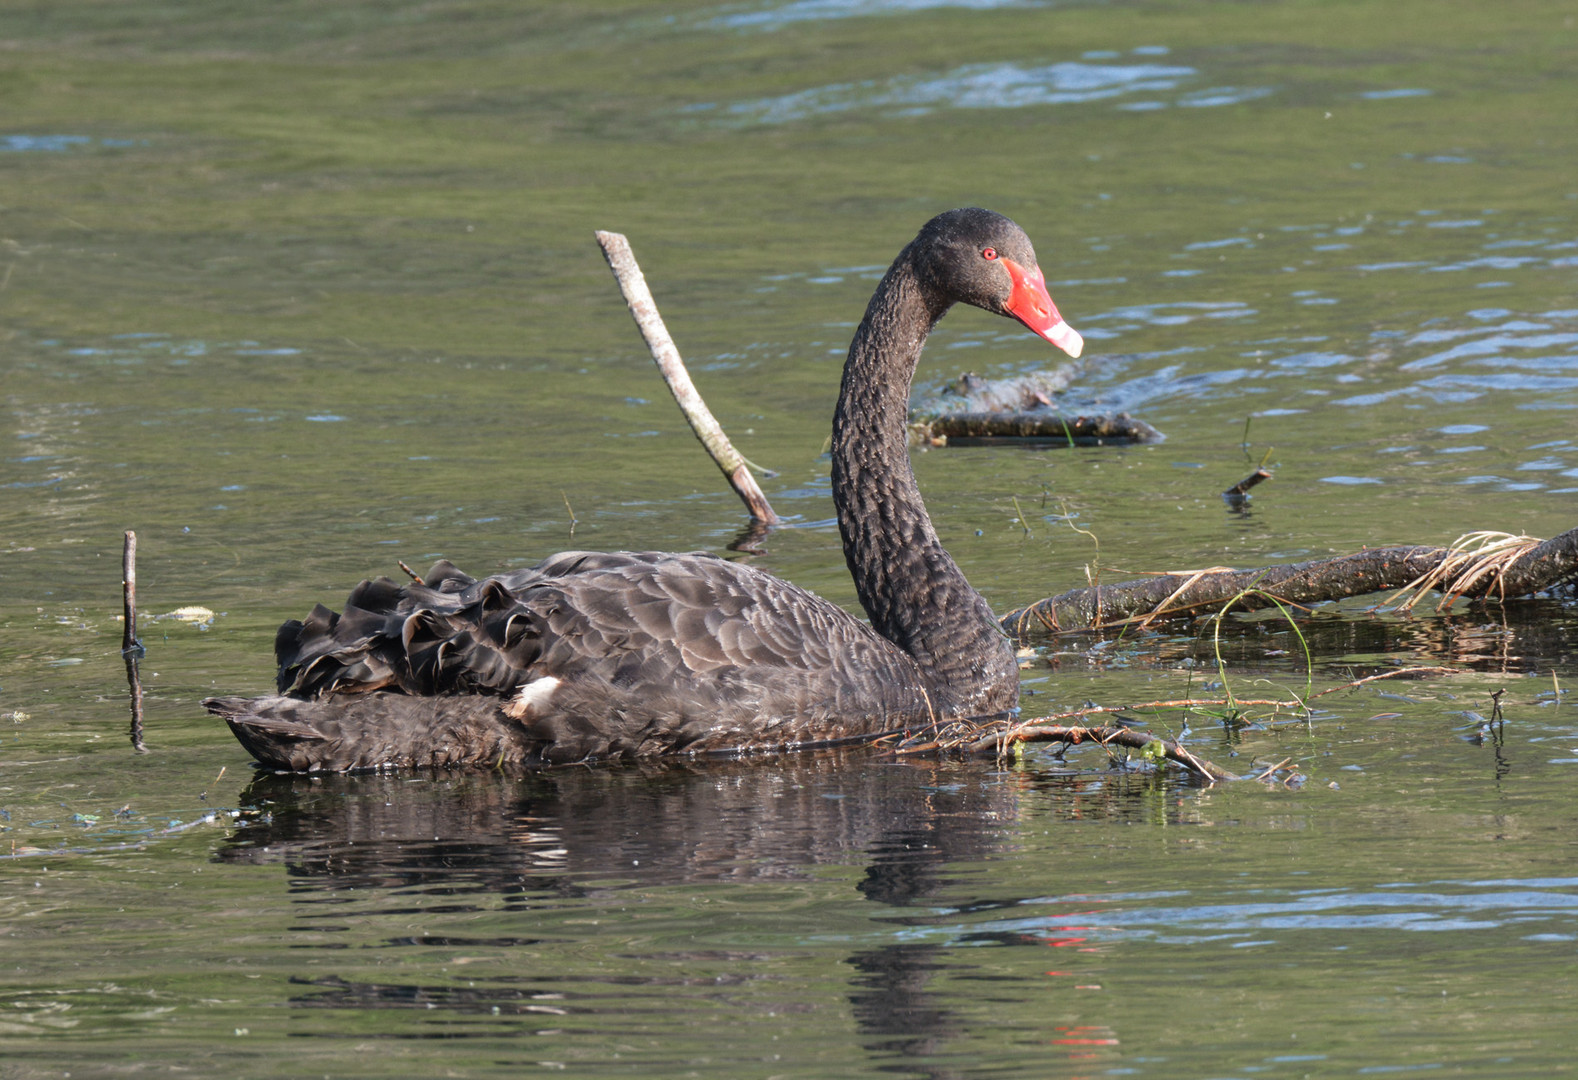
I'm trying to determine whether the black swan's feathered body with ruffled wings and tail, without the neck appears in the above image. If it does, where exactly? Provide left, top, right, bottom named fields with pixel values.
left=211, top=551, right=929, bottom=769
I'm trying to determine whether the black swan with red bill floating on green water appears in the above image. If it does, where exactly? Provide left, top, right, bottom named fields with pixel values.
left=204, top=208, right=1083, bottom=772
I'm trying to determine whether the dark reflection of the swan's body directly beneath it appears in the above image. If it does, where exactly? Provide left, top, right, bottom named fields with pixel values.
left=219, top=748, right=1019, bottom=906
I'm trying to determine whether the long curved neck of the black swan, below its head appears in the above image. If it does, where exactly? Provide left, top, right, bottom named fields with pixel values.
left=833, top=249, right=1019, bottom=715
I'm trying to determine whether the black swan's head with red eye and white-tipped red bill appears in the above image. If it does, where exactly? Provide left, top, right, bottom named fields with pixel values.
left=912, top=207, right=1084, bottom=357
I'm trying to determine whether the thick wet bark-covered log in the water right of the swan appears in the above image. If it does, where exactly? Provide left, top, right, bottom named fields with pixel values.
left=1000, top=529, right=1578, bottom=641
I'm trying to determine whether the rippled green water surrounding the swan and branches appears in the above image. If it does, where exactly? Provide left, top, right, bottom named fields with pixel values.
left=0, top=0, right=1578, bottom=1080
